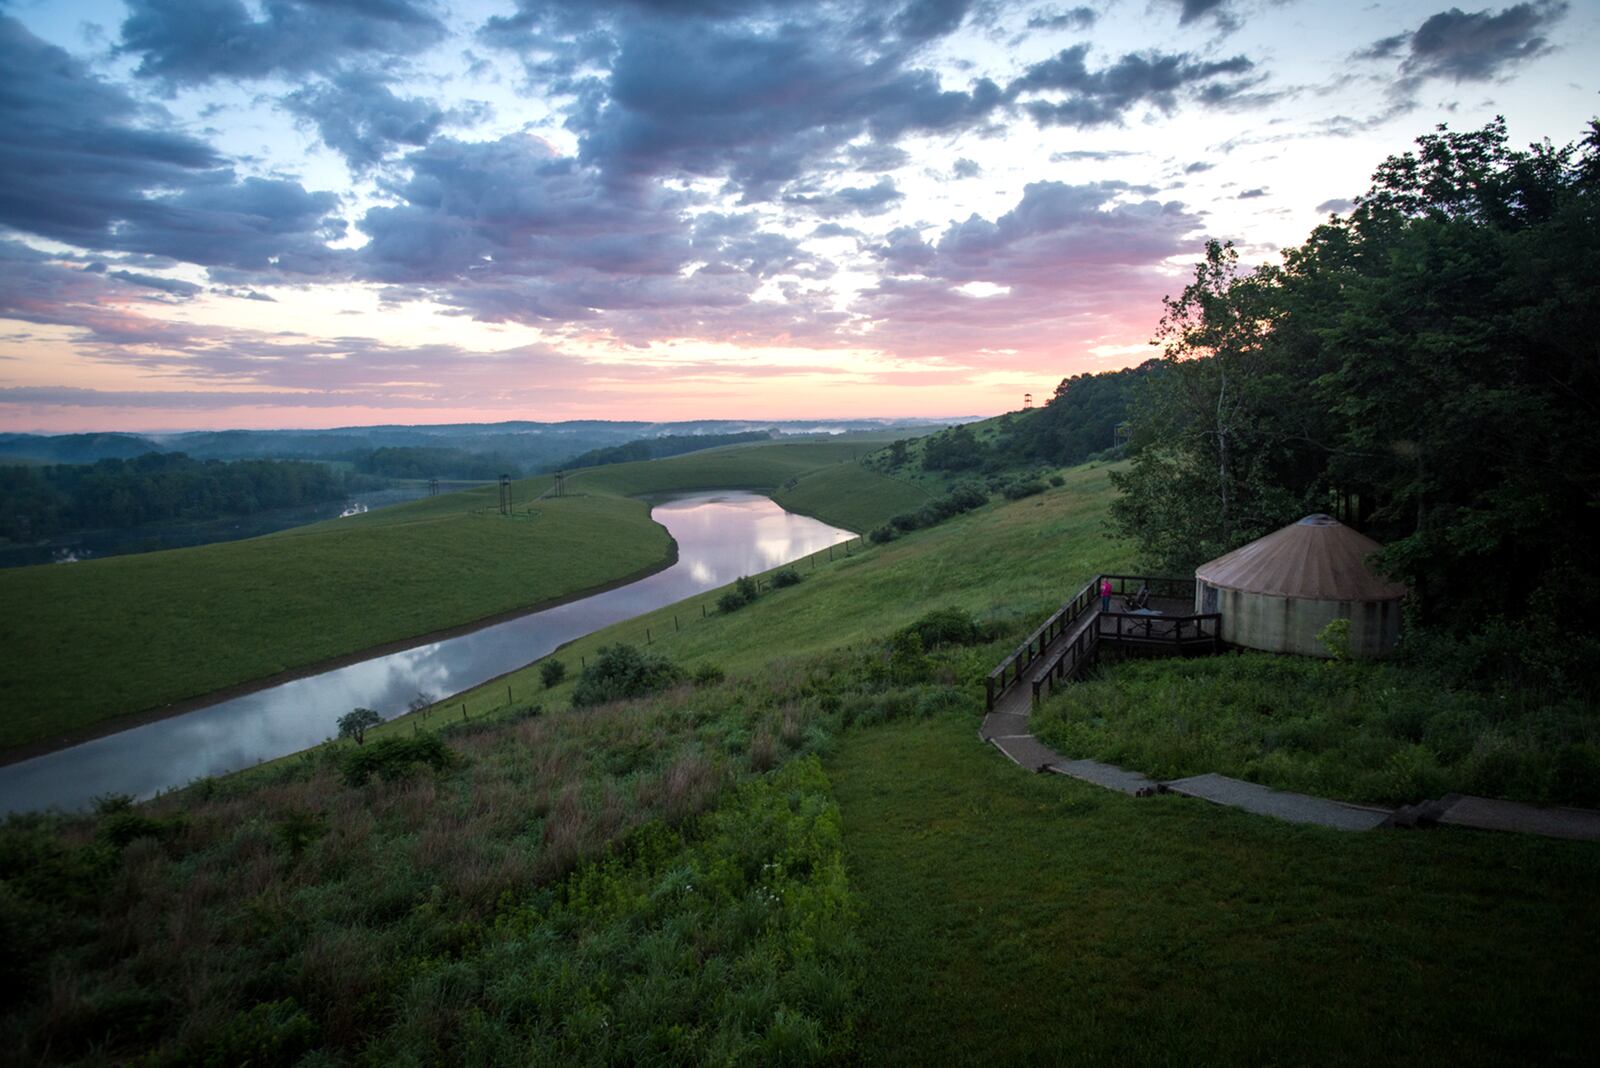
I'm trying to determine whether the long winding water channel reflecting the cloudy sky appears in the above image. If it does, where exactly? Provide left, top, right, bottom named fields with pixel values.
left=0, top=492, right=853, bottom=812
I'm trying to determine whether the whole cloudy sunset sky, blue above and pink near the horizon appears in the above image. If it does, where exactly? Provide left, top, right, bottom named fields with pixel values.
left=0, top=0, right=1600, bottom=432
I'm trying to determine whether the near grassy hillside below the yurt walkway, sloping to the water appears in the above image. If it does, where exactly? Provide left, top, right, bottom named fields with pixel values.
left=0, top=468, right=1600, bottom=1065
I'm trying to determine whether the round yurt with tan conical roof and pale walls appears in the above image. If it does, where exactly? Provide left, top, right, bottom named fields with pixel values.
left=1195, top=515, right=1405, bottom=657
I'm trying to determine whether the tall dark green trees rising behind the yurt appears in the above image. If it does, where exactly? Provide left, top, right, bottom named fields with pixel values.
left=1115, top=120, right=1600, bottom=646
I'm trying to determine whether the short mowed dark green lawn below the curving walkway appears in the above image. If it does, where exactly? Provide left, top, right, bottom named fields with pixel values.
left=827, top=708, right=1600, bottom=1065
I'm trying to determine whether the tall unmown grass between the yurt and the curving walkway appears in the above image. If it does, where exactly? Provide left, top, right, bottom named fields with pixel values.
left=1035, top=652, right=1600, bottom=806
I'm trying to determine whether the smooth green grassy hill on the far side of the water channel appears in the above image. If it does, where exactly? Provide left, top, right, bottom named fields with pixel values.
left=0, top=441, right=922, bottom=750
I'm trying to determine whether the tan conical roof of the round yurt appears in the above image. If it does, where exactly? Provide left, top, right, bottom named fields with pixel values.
left=1195, top=515, right=1405, bottom=601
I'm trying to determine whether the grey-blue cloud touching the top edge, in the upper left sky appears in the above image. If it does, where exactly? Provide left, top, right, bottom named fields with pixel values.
left=120, top=0, right=445, bottom=83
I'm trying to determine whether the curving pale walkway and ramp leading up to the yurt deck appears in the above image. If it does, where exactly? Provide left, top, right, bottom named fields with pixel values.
left=978, top=611, right=1600, bottom=841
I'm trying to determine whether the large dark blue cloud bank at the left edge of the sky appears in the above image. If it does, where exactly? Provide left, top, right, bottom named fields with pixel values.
left=0, top=18, right=344, bottom=275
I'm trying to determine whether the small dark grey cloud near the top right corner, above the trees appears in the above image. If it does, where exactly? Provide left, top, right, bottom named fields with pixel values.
left=1357, top=0, right=1568, bottom=83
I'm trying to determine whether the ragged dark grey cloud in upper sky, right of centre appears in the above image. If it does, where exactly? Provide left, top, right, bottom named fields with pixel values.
left=1006, top=45, right=1256, bottom=128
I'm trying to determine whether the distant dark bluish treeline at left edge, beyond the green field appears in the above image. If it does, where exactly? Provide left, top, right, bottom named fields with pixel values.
left=0, top=452, right=363, bottom=542
